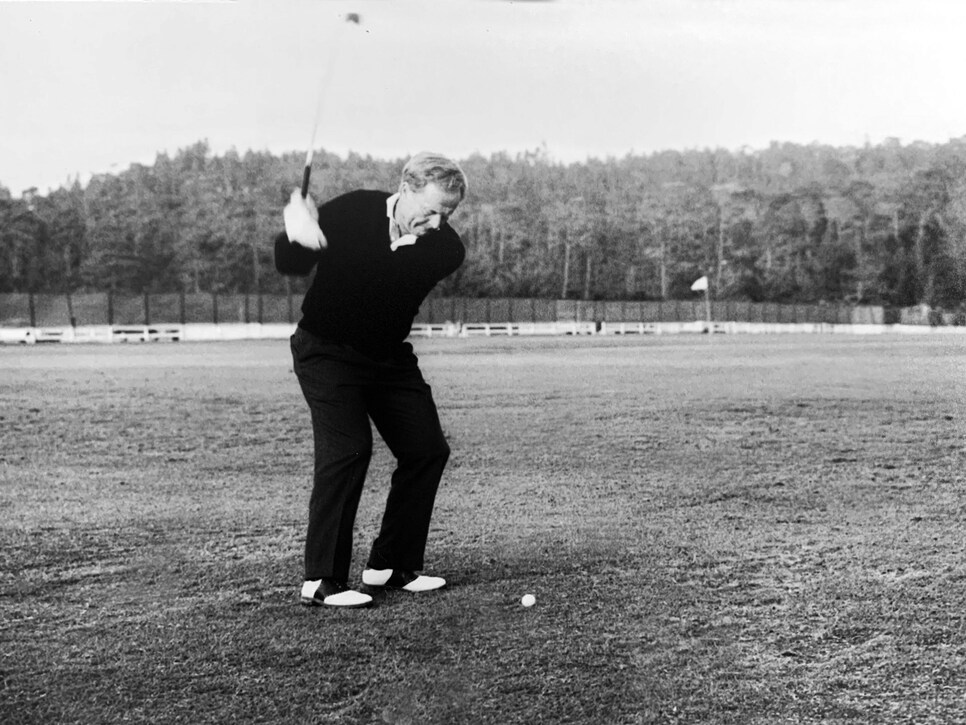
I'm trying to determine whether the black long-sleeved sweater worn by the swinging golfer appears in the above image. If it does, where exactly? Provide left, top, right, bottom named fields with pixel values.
left=275, top=190, right=466, bottom=360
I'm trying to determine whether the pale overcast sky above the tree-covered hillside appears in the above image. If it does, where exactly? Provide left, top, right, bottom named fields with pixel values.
left=0, top=0, right=966, bottom=195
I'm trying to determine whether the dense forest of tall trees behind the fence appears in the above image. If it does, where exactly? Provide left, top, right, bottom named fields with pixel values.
left=0, top=137, right=966, bottom=309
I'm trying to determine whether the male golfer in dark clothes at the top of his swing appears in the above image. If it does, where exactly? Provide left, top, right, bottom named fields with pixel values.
left=275, top=152, right=466, bottom=607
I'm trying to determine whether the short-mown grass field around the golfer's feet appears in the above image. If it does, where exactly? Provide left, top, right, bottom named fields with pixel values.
left=0, top=336, right=966, bottom=725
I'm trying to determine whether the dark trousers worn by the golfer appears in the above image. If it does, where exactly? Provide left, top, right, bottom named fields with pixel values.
left=292, top=328, right=450, bottom=582
